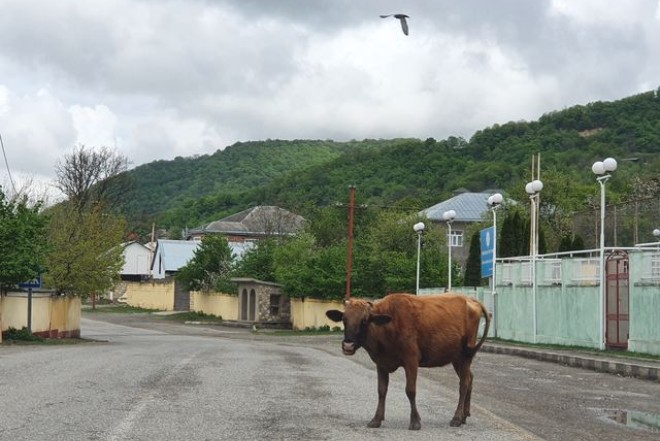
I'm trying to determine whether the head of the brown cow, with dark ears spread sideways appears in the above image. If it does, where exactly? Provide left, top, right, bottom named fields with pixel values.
left=325, top=299, right=392, bottom=355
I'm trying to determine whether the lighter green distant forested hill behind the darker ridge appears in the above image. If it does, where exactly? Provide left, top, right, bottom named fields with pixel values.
left=122, top=140, right=400, bottom=224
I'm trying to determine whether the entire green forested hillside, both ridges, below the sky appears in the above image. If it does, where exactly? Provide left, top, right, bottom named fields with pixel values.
left=125, top=91, right=660, bottom=237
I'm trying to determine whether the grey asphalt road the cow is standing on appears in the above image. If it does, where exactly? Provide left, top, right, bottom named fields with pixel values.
left=0, top=314, right=660, bottom=441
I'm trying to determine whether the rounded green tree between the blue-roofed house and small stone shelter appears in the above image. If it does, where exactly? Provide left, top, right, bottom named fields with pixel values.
left=175, top=234, right=234, bottom=292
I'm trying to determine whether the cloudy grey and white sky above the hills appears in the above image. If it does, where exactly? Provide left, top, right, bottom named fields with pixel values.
left=0, top=0, right=660, bottom=196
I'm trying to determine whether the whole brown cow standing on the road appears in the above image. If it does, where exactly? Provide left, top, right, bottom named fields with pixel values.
left=326, top=294, right=490, bottom=430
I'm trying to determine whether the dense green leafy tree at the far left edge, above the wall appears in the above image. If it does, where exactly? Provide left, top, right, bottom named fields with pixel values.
left=0, top=187, right=47, bottom=292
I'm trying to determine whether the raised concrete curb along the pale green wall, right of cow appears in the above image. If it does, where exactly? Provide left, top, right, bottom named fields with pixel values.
left=481, top=344, right=660, bottom=381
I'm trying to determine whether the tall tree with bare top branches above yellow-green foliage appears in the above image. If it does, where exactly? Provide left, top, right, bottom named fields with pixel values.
left=46, top=145, right=128, bottom=298
